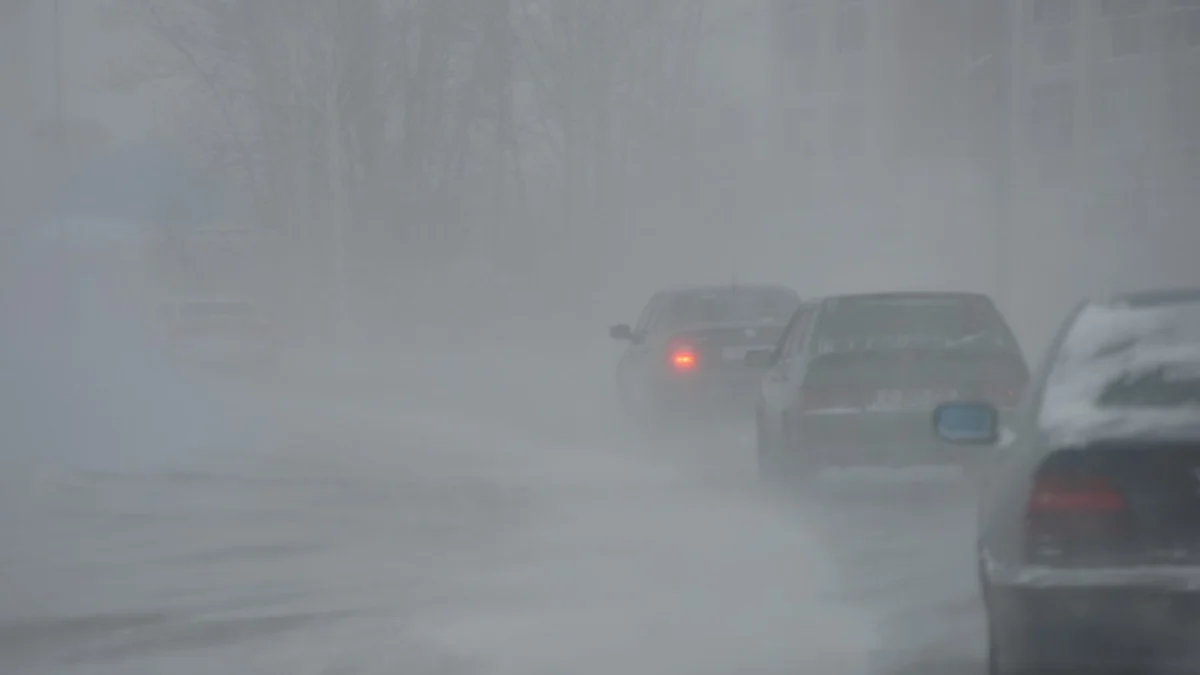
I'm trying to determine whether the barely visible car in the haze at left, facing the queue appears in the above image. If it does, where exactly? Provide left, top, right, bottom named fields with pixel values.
left=158, top=297, right=281, bottom=370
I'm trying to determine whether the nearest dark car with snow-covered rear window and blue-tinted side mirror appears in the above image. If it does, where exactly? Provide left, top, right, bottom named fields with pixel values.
left=932, top=289, right=1200, bottom=675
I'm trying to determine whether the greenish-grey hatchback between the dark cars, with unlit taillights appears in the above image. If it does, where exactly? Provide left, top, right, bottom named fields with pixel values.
left=746, top=292, right=1028, bottom=486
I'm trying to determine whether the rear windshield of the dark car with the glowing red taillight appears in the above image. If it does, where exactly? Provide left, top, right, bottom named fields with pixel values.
left=666, top=287, right=800, bottom=325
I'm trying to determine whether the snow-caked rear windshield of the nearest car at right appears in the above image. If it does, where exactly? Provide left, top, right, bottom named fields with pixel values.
left=1045, top=304, right=1200, bottom=408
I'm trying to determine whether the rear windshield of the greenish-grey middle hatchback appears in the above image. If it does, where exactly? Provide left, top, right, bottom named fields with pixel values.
left=816, top=295, right=1018, bottom=353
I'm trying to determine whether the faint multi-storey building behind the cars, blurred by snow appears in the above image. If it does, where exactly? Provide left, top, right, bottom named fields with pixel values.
left=772, top=0, right=1200, bottom=343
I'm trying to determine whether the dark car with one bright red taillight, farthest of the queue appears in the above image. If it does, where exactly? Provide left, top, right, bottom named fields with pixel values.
left=608, top=283, right=800, bottom=428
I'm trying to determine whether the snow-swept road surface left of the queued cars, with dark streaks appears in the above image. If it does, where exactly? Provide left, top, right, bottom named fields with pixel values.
left=0, top=341, right=982, bottom=675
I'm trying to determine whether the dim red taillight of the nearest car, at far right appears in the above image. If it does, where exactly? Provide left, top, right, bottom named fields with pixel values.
left=1025, top=474, right=1130, bottom=561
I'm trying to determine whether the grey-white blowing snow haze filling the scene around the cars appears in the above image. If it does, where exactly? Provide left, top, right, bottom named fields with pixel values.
left=0, top=0, right=1200, bottom=675
